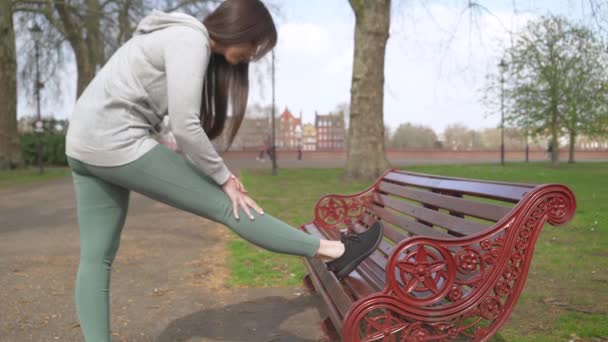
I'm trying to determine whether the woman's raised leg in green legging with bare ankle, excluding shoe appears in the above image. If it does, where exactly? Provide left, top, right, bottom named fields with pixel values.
left=71, top=144, right=328, bottom=257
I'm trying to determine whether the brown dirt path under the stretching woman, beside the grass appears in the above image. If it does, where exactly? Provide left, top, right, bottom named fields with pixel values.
left=0, top=178, right=323, bottom=342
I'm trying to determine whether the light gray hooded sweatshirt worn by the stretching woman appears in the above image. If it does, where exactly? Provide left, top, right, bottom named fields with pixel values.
left=65, top=10, right=230, bottom=184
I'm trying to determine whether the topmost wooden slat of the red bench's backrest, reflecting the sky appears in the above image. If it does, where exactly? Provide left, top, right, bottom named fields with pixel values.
left=385, top=172, right=532, bottom=203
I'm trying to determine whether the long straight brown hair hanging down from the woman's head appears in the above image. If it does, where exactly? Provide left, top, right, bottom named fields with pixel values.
left=200, top=0, right=277, bottom=149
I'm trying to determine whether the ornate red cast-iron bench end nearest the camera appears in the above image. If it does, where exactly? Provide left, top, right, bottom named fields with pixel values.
left=342, top=184, right=576, bottom=341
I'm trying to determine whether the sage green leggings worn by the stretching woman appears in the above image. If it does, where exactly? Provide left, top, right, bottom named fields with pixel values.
left=68, top=144, right=320, bottom=342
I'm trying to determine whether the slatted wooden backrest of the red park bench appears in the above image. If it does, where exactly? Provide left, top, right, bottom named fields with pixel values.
left=352, top=170, right=536, bottom=253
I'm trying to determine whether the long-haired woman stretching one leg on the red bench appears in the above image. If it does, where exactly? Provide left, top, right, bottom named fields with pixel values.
left=66, top=0, right=382, bottom=341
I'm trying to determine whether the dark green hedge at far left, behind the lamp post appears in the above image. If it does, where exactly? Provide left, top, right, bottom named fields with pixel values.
left=19, top=133, right=68, bottom=166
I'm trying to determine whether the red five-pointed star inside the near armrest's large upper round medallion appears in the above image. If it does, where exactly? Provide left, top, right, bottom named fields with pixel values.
left=397, top=245, right=446, bottom=294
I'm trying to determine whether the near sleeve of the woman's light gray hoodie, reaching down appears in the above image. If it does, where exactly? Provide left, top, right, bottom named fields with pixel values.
left=163, top=26, right=230, bottom=185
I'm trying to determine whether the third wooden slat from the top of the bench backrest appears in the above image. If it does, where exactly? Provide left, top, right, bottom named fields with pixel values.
left=372, top=192, right=488, bottom=236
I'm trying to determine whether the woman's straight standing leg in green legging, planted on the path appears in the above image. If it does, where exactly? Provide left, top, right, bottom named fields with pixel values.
left=68, top=158, right=129, bottom=342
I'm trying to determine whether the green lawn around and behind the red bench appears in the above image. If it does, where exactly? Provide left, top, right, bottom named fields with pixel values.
left=229, top=163, right=608, bottom=341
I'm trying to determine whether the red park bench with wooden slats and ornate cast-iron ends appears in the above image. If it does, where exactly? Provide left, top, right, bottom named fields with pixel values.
left=300, top=169, right=576, bottom=342
